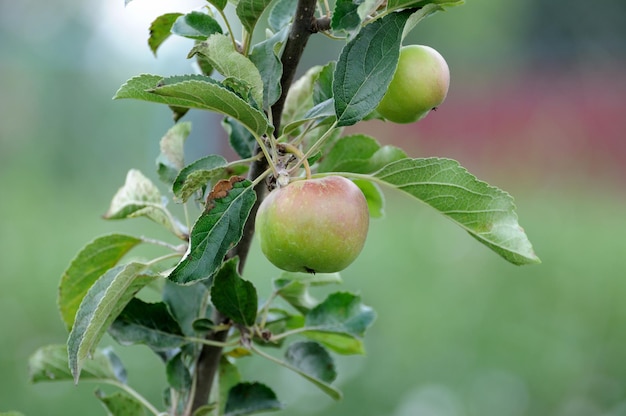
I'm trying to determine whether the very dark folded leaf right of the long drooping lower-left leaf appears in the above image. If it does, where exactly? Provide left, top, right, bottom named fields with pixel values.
left=109, top=298, right=186, bottom=351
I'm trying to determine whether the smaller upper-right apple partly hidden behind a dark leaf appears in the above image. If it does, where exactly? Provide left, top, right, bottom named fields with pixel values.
left=376, top=45, right=450, bottom=123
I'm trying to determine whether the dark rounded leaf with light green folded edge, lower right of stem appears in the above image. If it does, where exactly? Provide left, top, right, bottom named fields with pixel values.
left=285, top=341, right=341, bottom=400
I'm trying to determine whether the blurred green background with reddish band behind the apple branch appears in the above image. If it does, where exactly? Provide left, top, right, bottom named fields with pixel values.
left=0, top=0, right=626, bottom=416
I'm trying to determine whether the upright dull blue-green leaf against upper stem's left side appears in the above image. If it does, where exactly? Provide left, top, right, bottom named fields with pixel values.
left=250, top=26, right=289, bottom=109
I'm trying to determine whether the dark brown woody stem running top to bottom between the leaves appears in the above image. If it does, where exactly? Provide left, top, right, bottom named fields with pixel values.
left=186, top=0, right=320, bottom=416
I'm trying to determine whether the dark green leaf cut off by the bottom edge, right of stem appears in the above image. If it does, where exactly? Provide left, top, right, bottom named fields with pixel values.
left=224, top=383, right=283, bottom=416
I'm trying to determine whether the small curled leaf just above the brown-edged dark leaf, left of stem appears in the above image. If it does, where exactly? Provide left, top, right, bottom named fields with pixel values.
left=172, top=155, right=228, bottom=202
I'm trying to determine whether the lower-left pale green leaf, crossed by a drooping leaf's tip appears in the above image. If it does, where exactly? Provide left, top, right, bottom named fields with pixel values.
left=28, top=345, right=126, bottom=383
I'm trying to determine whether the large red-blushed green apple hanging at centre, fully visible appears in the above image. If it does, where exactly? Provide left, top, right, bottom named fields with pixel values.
left=255, top=176, right=369, bottom=273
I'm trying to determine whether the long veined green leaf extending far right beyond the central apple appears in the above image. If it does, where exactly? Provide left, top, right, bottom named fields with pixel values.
left=373, top=158, right=540, bottom=265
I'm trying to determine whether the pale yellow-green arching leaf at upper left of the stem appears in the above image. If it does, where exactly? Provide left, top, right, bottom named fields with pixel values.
left=187, top=34, right=263, bottom=105
